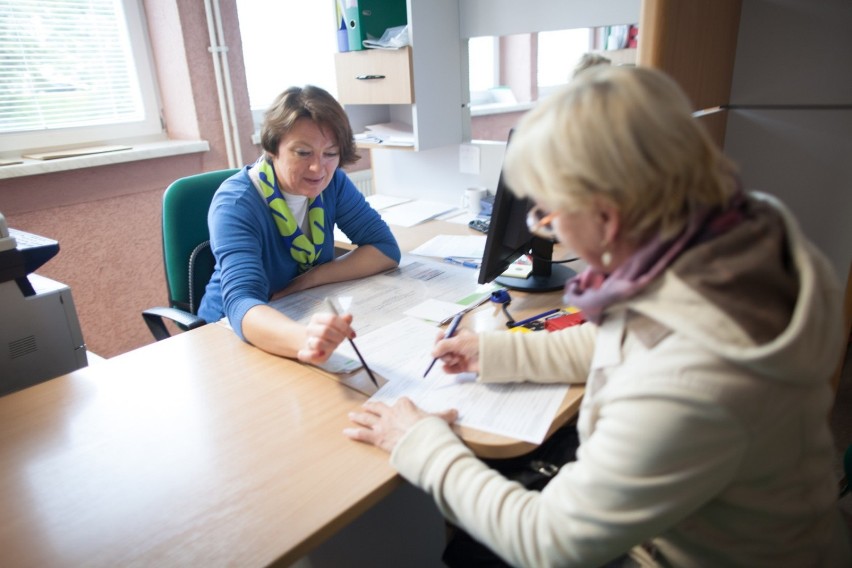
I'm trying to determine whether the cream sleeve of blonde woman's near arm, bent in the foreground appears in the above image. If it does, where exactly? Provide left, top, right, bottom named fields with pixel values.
left=391, top=397, right=747, bottom=567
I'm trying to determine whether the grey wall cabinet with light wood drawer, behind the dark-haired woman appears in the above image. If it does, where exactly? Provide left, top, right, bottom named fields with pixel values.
left=335, top=0, right=470, bottom=150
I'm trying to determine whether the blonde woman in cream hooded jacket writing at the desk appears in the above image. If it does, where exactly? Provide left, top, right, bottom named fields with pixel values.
left=346, top=66, right=852, bottom=567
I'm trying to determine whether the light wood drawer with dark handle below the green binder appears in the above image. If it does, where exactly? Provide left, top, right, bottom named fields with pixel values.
left=334, top=47, right=414, bottom=104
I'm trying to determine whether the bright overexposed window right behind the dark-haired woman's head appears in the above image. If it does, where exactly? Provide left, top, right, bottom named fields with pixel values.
left=237, top=0, right=337, bottom=116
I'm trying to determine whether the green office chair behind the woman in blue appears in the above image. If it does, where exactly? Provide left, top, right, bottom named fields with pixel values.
left=142, top=169, right=239, bottom=341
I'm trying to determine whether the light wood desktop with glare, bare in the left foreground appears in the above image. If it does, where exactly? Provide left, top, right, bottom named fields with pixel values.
left=0, top=219, right=582, bottom=566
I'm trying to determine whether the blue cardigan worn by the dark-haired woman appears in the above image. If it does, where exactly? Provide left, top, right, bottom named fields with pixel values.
left=198, top=166, right=400, bottom=339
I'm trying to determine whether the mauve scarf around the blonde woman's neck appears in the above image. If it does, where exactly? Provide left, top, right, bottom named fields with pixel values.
left=564, top=192, right=746, bottom=324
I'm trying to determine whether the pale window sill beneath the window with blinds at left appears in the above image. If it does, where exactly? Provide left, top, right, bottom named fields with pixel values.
left=0, top=140, right=210, bottom=179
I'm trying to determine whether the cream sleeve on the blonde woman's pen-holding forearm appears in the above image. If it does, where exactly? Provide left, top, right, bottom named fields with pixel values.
left=479, top=323, right=597, bottom=383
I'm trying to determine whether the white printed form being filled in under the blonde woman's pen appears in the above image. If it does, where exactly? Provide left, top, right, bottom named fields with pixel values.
left=338, top=318, right=569, bottom=444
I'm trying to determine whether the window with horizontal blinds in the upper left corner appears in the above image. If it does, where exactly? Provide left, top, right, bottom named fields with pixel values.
left=0, top=0, right=165, bottom=153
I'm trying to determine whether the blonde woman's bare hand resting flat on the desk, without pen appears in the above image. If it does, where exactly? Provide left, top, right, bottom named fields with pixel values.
left=343, top=397, right=459, bottom=453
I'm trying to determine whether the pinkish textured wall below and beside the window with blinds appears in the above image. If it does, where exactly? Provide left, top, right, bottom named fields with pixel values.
left=0, top=0, right=257, bottom=357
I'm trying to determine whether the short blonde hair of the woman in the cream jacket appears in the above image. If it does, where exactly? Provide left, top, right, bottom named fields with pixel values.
left=505, top=65, right=736, bottom=242
